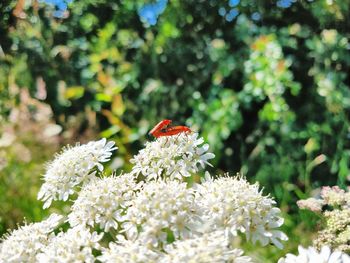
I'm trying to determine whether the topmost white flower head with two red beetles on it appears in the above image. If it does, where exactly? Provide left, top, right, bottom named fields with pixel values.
left=130, top=133, right=214, bottom=180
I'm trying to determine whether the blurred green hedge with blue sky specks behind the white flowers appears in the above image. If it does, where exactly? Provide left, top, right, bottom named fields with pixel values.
left=0, top=0, right=350, bottom=262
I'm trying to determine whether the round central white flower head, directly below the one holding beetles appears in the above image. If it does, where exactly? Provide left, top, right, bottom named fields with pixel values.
left=123, top=181, right=200, bottom=247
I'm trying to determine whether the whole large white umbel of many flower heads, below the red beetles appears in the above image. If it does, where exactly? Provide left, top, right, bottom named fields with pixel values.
left=0, top=134, right=287, bottom=263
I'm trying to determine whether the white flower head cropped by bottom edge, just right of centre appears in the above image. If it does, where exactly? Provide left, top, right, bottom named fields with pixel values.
left=160, top=231, right=251, bottom=263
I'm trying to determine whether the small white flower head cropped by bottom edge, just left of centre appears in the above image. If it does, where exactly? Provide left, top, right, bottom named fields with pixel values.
left=98, top=240, right=162, bottom=263
